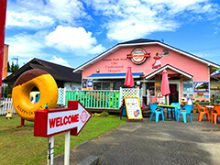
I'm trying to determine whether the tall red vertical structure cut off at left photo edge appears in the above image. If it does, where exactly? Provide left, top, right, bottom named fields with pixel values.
left=0, top=0, right=7, bottom=99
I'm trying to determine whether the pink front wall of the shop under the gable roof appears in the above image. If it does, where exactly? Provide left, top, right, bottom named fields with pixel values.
left=82, top=45, right=209, bottom=81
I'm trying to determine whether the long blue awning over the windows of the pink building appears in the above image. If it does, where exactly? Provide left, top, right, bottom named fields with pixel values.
left=87, top=72, right=144, bottom=79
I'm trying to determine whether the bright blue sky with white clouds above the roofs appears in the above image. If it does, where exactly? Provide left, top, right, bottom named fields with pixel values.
left=5, top=0, right=220, bottom=68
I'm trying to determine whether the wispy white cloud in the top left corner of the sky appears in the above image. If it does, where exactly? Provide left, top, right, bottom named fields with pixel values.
left=6, top=0, right=87, bottom=29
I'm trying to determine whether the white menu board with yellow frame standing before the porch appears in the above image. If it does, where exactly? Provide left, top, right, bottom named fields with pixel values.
left=125, top=97, right=143, bottom=120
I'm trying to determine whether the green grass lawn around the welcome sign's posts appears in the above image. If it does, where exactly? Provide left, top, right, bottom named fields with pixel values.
left=0, top=116, right=125, bottom=165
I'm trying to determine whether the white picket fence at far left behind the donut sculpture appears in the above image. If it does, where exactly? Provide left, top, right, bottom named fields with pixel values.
left=0, top=98, right=16, bottom=115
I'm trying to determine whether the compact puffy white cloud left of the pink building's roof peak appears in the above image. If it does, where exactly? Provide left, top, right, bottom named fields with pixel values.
left=45, top=26, right=105, bottom=56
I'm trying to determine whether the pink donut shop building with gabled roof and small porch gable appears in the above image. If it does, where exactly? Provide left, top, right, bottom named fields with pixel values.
left=75, top=39, right=220, bottom=102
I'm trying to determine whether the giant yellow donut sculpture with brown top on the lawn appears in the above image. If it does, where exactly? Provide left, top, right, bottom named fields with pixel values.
left=12, top=69, right=58, bottom=121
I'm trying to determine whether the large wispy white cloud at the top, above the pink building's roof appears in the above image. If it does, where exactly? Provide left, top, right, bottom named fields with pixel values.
left=86, top=0, right=217, bottom=41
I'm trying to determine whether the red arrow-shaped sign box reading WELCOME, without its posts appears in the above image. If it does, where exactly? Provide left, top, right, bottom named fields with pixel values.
left=34, top=101, right=91, bottom=137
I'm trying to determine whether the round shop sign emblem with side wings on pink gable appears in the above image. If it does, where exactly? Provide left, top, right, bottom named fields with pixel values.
left=127, top=48, right=150, bottom=65
